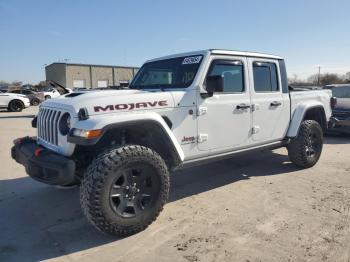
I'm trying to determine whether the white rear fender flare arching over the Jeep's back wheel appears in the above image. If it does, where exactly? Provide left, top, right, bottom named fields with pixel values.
left=287, top=103, right=327, bottom=137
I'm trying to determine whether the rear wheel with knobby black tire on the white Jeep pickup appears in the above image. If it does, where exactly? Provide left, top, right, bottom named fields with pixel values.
left=287, top=120, right=323, bottom=168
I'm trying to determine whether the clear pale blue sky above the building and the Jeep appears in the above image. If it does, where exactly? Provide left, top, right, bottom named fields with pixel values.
left=0, top=0, right=350, bottom=83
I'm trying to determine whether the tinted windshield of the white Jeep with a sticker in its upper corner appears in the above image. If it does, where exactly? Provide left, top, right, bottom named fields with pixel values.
left=130, top=55, right=203, bottom=89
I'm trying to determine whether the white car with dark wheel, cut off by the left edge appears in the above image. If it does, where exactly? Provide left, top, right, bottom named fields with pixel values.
left=0, top=93, right=30, bottom=112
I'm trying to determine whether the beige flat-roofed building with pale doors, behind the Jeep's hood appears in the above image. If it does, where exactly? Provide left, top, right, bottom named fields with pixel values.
left=45, top=63, right=139, bottom=88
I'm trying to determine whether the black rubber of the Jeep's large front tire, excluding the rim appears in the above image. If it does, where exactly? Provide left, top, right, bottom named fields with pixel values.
left=80, top=145, right=169, bottom=236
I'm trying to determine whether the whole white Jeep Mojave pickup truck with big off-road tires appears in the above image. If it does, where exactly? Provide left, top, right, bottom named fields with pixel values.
left=12, top=50, right=331, bottom=235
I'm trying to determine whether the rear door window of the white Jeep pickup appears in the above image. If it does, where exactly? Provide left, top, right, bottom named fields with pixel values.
left=253, top=62, right=279, bottom=93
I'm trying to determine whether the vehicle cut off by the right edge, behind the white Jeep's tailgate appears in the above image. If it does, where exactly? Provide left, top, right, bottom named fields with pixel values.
left=324, top=84, right=350, bottom=134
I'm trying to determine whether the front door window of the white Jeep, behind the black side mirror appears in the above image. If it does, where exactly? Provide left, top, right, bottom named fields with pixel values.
left=208, top=61, right=244, bottom=93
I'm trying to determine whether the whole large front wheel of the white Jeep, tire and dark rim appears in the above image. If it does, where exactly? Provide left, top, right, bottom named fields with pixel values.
left=80, top=145, right=169, bottom=236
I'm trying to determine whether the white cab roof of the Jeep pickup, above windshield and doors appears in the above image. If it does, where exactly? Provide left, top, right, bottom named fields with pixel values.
left=147, top=49, right=283, bottom=62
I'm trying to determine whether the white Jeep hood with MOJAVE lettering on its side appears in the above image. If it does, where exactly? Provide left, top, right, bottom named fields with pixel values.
left=42, top=90, right=175, bottom=116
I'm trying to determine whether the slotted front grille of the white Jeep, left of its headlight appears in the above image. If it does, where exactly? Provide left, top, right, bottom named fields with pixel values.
left=37, top=108, right=62, bottom=146
